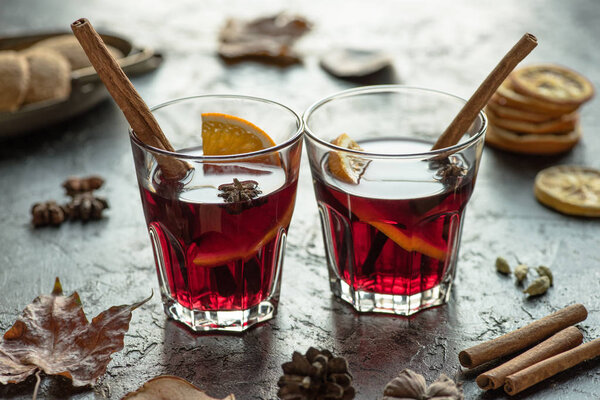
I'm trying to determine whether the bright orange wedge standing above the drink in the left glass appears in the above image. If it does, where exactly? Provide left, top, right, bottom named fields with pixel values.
left=202, top=113, right=279, bottom=164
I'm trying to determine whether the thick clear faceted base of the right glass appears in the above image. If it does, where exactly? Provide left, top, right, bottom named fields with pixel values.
left=331, top=278, right=452, bottom=316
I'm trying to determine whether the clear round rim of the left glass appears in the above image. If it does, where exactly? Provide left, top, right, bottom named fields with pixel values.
left=128, top=94, right=304, bottom=161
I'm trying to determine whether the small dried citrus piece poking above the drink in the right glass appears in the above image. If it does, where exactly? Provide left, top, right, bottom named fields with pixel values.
left=327, top=133, right=369, bottom=185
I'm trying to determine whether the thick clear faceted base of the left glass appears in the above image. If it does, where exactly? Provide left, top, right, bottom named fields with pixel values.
left=163, top=295, right=277, bottom=332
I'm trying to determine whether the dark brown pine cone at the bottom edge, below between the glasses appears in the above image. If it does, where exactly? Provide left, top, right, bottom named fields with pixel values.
left=277, top=347, right=355, bottom=400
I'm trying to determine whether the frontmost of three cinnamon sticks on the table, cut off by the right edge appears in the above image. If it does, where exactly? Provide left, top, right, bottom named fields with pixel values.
left=504, top=339, right=600, bottom=396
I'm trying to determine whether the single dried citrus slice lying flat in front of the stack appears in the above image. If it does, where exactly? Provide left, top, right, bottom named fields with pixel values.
left=534, top=165, right=600, bottom=217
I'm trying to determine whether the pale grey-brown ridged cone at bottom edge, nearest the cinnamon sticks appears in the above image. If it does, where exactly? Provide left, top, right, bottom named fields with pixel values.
left=382, top=369, right=464, bottom=400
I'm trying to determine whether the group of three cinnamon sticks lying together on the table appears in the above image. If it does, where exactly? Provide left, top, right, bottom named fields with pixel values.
left=458, top=304, right=600, bottom=396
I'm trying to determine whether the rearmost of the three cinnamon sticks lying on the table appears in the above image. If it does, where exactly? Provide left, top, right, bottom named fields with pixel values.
left=458, top=304, right=587, bottom=368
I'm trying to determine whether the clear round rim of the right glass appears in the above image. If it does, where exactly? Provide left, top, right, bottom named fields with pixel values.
left=302, top=84, right=488, bottom=159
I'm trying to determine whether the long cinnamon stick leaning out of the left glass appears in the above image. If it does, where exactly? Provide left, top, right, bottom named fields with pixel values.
left=71, top=18, right=190, bottom=179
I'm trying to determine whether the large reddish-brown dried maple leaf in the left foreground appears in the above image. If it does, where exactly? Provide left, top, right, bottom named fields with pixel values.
left=0, top=278, right=152, bottom=386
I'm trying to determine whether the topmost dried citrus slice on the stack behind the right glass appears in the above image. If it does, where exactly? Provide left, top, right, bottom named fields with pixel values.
left=510, top=64, right=594, bottom=105
